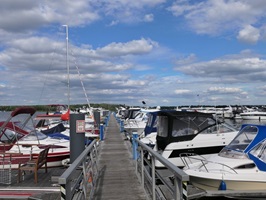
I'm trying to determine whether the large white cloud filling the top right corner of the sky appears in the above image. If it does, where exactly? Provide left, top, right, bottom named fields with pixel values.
left=168, top=0, right=266, bottom=41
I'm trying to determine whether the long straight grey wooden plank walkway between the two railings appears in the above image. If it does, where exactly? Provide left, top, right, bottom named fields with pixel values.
left=93, top=115, right=147, bottom=200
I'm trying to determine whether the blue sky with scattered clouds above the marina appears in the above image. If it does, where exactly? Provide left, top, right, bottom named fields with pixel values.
left=0, top=0, right=266, bottom=106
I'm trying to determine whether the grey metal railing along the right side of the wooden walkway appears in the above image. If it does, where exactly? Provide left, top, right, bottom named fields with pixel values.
left=132, top=136, right=189, bottom=200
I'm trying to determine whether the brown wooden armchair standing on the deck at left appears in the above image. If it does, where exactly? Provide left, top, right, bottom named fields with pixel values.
left=18, top=147, right=50, bottom=183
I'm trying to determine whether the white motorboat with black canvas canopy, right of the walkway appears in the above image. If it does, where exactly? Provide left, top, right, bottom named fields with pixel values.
left=154, top=111, right=238, bottom=168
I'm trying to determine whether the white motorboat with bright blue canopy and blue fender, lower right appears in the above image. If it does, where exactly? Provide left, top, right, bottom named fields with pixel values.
left=184, top=124, right=266, bottom=191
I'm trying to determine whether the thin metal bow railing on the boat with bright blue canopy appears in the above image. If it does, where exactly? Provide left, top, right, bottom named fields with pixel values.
left=180, top=153, right=237, bottom=174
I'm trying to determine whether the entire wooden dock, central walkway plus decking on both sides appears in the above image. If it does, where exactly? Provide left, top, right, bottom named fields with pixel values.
left=0, top=111, right=266, bottom=200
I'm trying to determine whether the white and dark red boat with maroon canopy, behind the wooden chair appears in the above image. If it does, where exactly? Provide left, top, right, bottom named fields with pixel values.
left=0, top=107, right=70, bottom=168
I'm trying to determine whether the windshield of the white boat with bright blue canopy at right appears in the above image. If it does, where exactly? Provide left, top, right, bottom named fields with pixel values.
left=219, top=126, right=258, bottom=158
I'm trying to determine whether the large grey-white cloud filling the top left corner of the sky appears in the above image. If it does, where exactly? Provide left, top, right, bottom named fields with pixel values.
left=0, top=0, right=100, bottom=32
